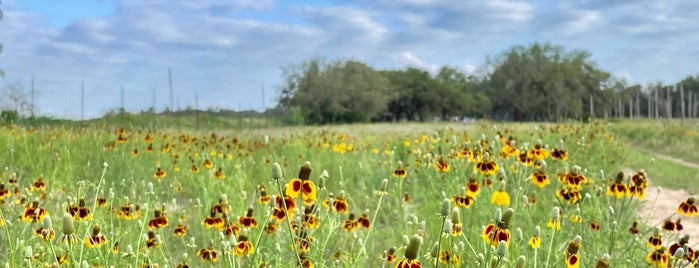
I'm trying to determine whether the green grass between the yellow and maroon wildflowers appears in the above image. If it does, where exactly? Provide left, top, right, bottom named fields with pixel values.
left=0, top=118, right=691, bottom=267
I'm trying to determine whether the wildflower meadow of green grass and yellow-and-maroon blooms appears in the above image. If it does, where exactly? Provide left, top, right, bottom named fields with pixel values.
left=0, top=121, right=699, bottom=268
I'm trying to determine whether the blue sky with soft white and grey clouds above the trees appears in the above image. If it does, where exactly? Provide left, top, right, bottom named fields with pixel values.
left=0, top=0, right=699, bottom=118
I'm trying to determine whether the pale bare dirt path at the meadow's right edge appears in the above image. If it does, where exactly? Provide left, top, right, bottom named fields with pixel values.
left=636, top=152, right=699, bottom=245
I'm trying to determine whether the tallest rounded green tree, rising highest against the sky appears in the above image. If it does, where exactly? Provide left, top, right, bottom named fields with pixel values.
left=484, top=43, right=610, bottom=121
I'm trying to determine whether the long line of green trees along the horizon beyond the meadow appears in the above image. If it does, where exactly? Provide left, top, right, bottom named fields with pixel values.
left=275, top=43, right=699, bottom=124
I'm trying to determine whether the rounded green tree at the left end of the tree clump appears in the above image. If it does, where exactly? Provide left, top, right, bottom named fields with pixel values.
left=280, top=59, right=391, bottom=124
